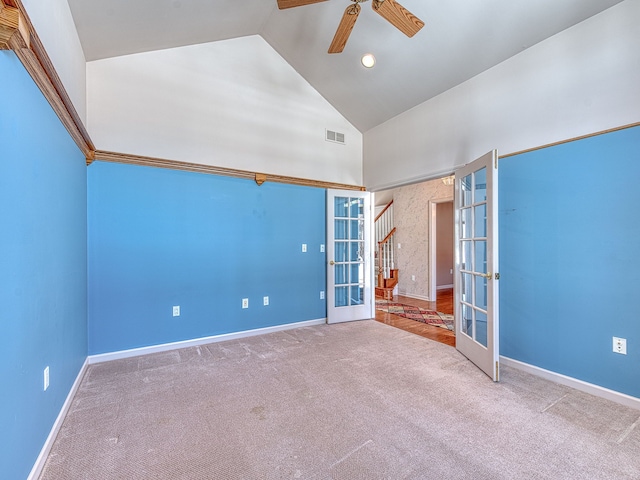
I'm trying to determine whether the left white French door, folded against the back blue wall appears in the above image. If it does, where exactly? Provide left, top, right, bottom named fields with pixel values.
left=327, top=189, right=374, bottom=323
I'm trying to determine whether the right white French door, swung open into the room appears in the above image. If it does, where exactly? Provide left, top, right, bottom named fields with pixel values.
left=455, top=150, right=500, bottom=382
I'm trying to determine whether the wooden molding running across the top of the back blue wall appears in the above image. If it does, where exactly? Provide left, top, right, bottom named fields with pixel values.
left=92, top=150, right=366, bottom=191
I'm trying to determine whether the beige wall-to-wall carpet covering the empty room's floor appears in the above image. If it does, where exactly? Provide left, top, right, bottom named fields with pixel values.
left=41, top=321, right=640, bottom=480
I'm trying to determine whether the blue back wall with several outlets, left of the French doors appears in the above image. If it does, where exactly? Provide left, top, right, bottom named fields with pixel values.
left=88, top=162, right=326, bottom=354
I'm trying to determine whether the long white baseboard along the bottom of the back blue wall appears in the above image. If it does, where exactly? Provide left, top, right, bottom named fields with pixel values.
left=87, top=318, right=327, bottom=365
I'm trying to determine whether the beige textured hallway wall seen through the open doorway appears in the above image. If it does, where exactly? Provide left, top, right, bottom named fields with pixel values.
left=393, top=180, right=453, bottom=299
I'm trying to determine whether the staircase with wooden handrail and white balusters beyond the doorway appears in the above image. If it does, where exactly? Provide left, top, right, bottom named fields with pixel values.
left=375, top=200, right=398, bottom=300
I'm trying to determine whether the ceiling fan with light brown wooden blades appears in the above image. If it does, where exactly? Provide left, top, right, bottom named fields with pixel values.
left=278, top=0, right=424, bottom=53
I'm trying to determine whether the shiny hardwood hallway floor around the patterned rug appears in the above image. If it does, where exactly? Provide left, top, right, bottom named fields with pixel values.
left=376, top=288, right=456, bottom=347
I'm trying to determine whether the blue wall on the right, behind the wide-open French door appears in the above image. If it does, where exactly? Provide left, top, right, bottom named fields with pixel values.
left=499, top=127, right=640, bottom=397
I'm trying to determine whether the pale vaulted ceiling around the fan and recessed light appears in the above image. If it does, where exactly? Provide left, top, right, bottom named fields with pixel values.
left=68, top=0, right=621, bottom=132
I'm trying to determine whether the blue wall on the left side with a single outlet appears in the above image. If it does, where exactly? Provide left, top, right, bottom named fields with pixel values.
left=0, top=51, right=87, bottom=480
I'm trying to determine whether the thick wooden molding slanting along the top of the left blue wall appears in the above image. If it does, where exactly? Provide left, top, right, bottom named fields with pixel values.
left=0, top=0, right=95, bottom=158
